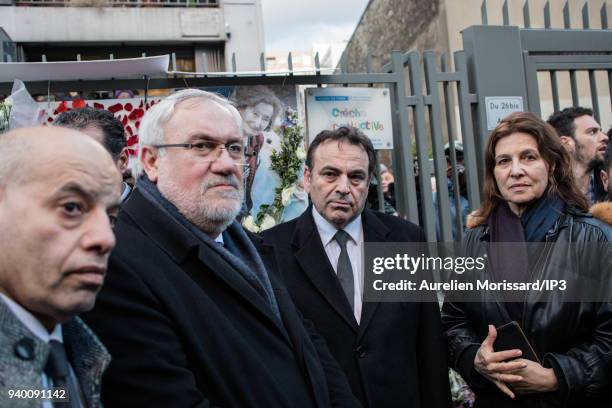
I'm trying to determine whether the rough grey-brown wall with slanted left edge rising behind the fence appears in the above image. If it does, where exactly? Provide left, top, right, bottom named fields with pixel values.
left=344, top=0, right=448, bottom=72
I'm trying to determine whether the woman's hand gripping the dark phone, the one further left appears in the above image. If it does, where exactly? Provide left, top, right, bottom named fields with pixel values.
left=474, top=325, right=524, bottom=398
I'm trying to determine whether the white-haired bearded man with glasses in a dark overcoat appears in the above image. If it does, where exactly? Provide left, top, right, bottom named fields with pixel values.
left=81, top=89, right=358, bottom=408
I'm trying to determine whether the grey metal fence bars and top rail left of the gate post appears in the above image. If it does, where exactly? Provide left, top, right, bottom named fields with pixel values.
left=0, top=47, right=479, bottom=241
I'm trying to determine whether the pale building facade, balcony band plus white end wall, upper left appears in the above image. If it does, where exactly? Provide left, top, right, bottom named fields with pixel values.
left=0, top=0, right=264, bottom=71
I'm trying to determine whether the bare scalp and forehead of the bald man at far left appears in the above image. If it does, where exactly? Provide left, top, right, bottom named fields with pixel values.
left=0, top=126, right=117, bottom=187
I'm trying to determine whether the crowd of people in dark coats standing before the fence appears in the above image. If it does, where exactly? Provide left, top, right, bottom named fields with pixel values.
left=0, top=89, right=612, bottom=408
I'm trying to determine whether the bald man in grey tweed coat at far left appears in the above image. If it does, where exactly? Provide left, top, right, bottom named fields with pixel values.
left=0, top=127, right=121, bottom=408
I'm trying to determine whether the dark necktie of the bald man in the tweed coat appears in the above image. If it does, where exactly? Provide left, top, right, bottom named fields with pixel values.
left=44, top=340, right=82, bottom=408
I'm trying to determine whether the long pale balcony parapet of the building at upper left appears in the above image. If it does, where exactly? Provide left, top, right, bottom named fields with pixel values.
left=0, top=7, right=225, bottom=43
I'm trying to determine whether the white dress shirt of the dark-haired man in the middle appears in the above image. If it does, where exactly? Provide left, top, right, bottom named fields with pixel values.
left=312, top=206, right=363, bottom=323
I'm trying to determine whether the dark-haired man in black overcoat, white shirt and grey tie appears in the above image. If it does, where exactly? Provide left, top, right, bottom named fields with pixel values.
left=263, top=127, right=451, bottom=408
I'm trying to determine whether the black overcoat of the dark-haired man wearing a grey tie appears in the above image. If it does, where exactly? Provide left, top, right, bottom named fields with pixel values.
left=263, top=207, right=451, bottom=408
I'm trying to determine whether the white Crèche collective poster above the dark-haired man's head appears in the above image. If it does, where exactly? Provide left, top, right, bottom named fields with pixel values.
left=306, top=88, right=393, bottom=150
